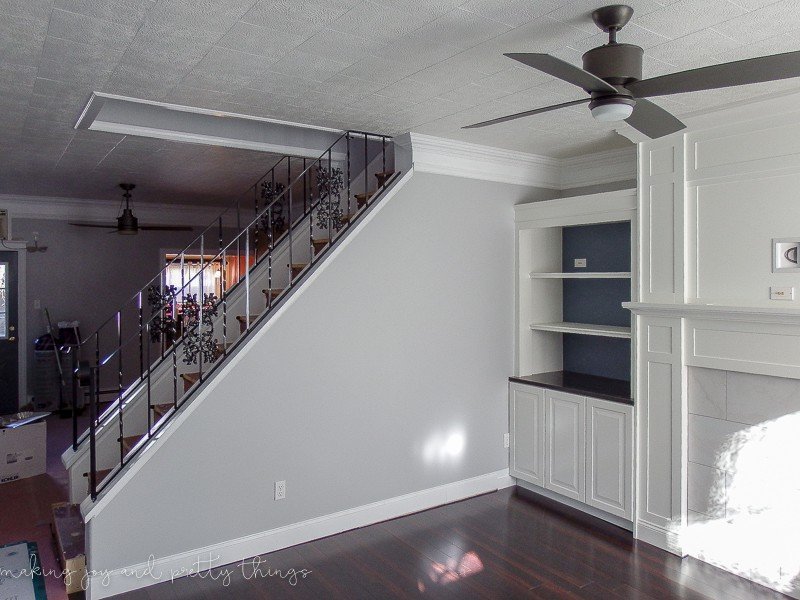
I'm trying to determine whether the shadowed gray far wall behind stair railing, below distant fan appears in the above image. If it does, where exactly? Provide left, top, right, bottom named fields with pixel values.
left=14, top=219, right=201, bottom=395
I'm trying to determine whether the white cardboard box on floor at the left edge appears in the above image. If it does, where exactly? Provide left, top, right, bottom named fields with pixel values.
left=0, top=421, right=47, bottom=483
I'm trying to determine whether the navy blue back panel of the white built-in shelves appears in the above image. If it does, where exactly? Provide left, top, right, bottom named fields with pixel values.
left=562, top=222, right=631, bottom=381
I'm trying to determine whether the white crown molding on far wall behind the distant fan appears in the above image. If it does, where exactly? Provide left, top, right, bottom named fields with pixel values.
left=0, top=194, right=231, bottom=227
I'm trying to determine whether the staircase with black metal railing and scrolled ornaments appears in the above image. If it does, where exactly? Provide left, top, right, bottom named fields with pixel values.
left=52, top=131, right=399, bottom=592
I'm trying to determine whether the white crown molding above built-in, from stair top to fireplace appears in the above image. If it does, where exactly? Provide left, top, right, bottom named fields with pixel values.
left=409, top=132, right=636, bottom=190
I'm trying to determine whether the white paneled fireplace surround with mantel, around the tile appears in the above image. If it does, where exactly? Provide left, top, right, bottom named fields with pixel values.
left=626, top=93, right=800, bottom=598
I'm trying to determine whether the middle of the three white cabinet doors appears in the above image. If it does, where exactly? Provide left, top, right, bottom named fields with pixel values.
left=545, top=391, right=586, bottom=502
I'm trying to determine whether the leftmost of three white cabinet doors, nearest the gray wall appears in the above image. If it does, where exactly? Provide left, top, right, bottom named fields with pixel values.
left=509, top=383, right=544, bottom=486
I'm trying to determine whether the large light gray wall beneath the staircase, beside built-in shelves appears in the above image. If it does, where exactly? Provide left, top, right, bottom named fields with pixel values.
left=81, top=173, right=554, bottom=585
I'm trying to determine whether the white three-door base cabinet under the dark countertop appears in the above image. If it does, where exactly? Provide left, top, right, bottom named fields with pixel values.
left=509, top=382, right=633, bottom=520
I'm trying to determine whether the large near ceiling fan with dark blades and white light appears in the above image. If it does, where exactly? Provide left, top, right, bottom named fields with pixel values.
left=463, top=4, right=800, bottom=138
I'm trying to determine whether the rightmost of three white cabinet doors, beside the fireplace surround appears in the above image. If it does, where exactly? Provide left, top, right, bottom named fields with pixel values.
left=586, top=398, right=633, bottom=519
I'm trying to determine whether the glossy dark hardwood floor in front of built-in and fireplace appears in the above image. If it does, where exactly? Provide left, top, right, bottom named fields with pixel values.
left=118, top=489, right=787, bottom=600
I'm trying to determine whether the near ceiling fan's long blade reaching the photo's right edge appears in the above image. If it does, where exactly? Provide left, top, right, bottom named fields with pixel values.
left=627, top=51, right=800, bottom=98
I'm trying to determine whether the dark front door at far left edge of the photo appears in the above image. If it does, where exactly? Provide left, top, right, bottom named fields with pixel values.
left=0, top=252, right=20, bottom=415
